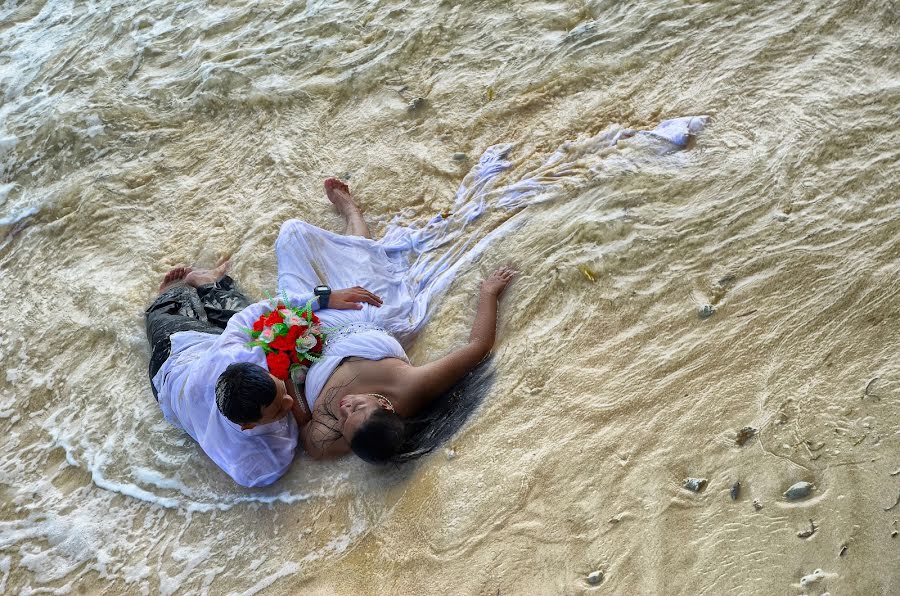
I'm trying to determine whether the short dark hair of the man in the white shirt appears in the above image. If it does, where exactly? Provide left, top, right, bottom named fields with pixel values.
left=216, top=362, right=278, bottom=424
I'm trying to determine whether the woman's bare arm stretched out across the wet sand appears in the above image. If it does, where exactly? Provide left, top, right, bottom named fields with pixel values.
left=400, top=267, right=516, bottom=416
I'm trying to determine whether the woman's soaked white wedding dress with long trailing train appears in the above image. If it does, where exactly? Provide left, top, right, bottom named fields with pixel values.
left=275, top=116, right=708, bottom=408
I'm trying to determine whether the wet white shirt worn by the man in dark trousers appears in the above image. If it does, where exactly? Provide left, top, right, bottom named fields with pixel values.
left=152, top=296, right=312, bottom=487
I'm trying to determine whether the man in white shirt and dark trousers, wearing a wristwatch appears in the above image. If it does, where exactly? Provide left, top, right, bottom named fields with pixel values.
left=145, top=261, right=381, bottom=487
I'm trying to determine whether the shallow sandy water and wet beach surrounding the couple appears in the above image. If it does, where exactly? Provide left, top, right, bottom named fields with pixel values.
left=0, top=0, right=900, bottom=594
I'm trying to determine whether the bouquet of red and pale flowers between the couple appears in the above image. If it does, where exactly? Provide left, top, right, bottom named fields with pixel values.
left=245, top=299, right=325, bottom=382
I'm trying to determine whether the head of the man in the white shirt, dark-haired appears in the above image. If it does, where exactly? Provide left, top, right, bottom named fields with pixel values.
left=216, top=362, right=294, bottom=430
